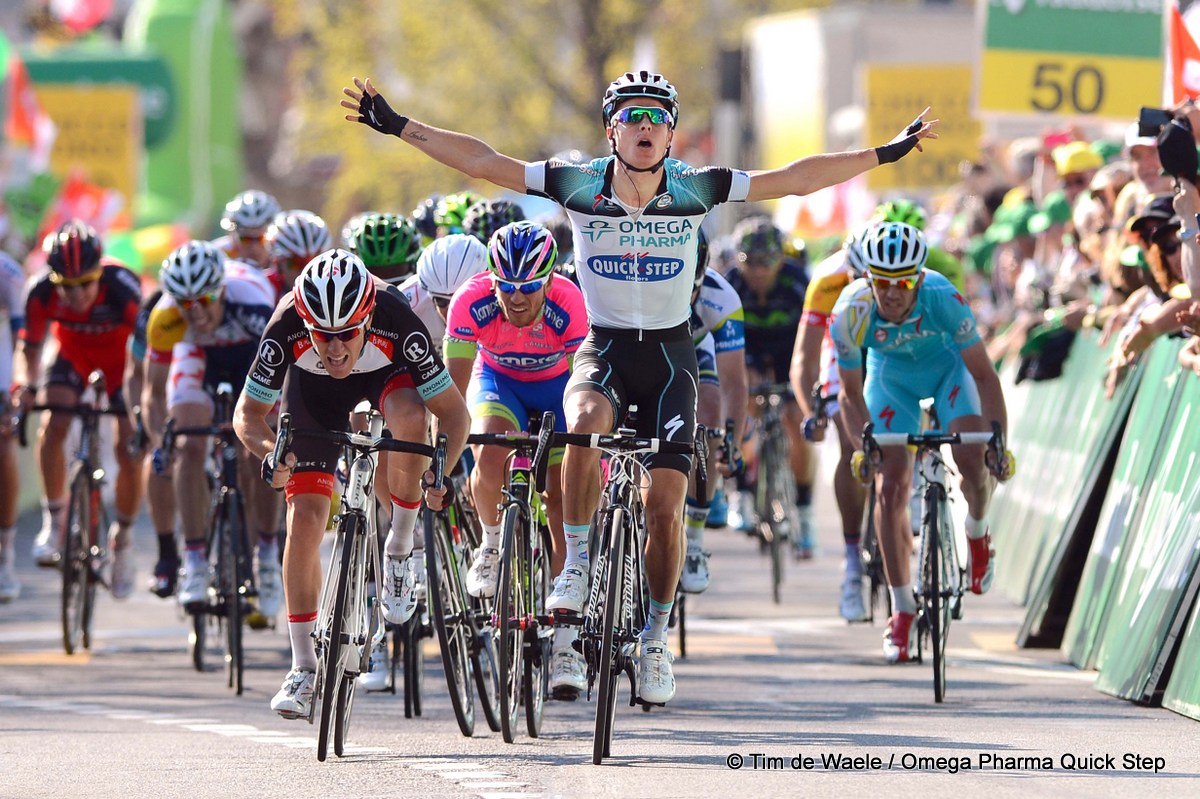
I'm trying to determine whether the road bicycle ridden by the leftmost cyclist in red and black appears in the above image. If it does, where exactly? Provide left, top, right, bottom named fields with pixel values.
left=17, top=370, right=125, bottom=655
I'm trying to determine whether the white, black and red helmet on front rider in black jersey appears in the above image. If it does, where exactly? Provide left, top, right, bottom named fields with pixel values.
left=292, top=250, right=376, bottom=330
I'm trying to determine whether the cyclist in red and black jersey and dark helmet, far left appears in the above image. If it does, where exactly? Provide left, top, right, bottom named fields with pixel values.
left=12, top=220, right=142, bottom=599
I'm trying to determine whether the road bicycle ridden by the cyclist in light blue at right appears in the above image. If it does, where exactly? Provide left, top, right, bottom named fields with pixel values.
left=863, top=422, right=1004, bottom=702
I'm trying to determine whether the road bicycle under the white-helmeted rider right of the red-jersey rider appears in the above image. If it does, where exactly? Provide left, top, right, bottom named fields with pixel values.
left=162, top=383, right=258, bottom=696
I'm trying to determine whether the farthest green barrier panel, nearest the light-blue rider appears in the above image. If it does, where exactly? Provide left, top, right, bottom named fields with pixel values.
left=989, top=330, right=1141, bottom=605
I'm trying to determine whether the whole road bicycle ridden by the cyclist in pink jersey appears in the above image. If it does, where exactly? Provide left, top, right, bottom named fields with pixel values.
left=467, top=411, right=554, bottom=744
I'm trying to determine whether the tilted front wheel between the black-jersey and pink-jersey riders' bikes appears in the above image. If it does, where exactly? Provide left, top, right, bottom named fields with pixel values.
left=422, top=509, right=475, bottom=738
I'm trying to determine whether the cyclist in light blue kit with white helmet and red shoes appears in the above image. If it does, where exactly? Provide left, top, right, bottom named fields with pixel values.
left=829, top=222, right=1015, bottom=662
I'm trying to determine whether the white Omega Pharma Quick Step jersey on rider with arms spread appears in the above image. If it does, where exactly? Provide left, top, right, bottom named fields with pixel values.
left=526, top=156, right=750, bottom=330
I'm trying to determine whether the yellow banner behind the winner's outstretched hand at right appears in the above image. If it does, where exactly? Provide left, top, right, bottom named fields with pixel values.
left=863, top=64, right=980, bottom=193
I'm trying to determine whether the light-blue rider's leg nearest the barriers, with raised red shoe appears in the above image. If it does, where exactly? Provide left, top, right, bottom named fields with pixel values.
left=936, top=365, right=996, bottom=594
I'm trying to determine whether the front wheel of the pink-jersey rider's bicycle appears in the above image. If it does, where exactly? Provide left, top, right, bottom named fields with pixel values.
left=496, top=505, right=528, bottom=744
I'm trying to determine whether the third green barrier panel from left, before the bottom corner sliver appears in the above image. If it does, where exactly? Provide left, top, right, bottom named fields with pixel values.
left=1096, top=364, right=1200, bottom=703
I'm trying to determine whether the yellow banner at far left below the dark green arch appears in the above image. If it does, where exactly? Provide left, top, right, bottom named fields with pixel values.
left=37, top=84, right=143, bottom=209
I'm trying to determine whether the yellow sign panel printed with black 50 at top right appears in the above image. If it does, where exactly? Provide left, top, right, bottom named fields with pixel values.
left=979, top=50, right=1163, bottom=119
